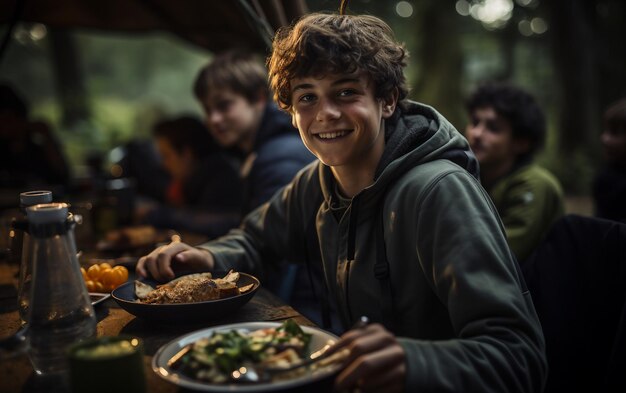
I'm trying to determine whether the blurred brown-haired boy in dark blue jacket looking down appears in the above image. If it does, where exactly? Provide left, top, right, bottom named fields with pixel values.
left=194, top=50, right=323, bottom=322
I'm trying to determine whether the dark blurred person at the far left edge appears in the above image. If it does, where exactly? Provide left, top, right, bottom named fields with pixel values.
left=0, top=84, right=70, bottom=194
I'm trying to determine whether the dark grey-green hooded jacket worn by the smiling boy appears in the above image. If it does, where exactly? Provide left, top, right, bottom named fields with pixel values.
left=202, top=103, right=547, bottom=392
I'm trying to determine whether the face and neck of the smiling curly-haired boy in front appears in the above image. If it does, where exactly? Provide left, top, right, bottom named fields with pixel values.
left=292, top=71, right=397, bottom=198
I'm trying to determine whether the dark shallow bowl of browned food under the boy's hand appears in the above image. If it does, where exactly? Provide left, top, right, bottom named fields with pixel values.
left=111, top=271, right=260, bottom=323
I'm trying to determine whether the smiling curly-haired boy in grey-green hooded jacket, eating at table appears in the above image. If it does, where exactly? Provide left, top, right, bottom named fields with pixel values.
left=137, top=10, right=547, bottom=392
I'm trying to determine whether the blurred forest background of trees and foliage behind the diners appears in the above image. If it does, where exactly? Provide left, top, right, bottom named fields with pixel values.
left=0, top=0, right=626, bottom=212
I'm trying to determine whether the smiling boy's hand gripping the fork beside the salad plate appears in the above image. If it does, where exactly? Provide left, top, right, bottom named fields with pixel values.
left=332, top=324, right=406, bottom=393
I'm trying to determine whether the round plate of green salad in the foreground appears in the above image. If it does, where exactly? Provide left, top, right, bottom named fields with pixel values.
left=152, top=320, right=341, bottom=392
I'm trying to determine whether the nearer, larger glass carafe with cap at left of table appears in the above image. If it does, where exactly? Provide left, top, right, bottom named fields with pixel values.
left=26, top=203, right=96, bottom=375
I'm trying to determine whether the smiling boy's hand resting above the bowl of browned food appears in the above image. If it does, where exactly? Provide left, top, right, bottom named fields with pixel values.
left=135, top=242, right=214, bottom=281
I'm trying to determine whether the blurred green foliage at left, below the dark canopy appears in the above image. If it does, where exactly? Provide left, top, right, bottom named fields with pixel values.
left=0, top=27, right=210, bottom=168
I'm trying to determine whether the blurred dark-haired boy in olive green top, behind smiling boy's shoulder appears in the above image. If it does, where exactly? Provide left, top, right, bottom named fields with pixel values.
left=465, top=83, right=564, bottom=263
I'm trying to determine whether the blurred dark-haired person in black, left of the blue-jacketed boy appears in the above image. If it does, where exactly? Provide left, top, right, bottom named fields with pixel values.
left=138, top=117, right=243, bottom=238
